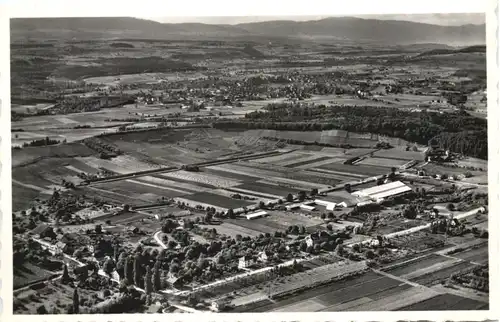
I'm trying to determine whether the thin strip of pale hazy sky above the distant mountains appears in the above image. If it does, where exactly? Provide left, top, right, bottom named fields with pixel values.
left=147, top=13, right=486, bottom=26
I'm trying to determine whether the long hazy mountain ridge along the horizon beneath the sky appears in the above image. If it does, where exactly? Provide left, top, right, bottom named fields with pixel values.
left=10, top=17, right=486, bottom=46
